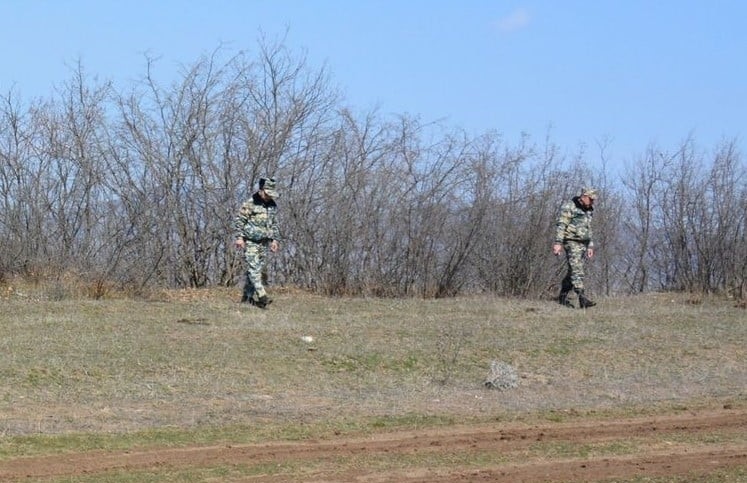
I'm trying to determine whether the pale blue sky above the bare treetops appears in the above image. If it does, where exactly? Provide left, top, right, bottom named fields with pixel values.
left=0, top=0, right=747, bottom=163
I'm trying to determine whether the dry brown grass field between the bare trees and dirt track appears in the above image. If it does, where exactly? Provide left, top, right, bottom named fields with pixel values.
left=0, top=286, right=747, bottom=435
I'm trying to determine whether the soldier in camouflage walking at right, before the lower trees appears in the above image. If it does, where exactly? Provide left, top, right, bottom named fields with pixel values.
left=552, top=188, right=597, bottom=309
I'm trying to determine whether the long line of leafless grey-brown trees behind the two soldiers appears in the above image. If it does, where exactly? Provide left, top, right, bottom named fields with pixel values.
left=0, top=42, right=747, bottom=297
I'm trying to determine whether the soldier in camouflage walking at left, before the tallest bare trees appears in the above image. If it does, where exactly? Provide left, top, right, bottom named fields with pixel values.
left=234, top=178, right=280, bottom=309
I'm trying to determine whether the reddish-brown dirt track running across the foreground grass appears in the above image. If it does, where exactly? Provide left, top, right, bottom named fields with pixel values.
left=0, top=408, right=747, bottom=483
